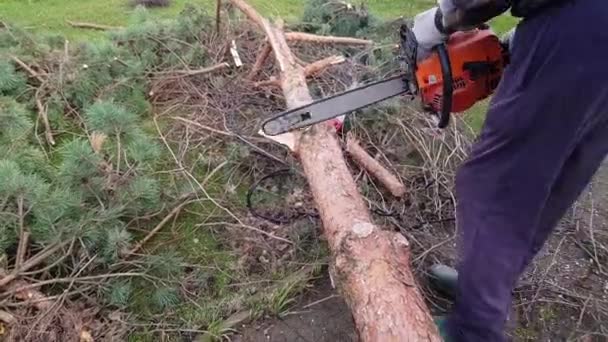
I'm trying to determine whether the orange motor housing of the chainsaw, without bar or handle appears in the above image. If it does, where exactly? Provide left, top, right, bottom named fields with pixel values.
left=416, top=29, right=507, bottom=113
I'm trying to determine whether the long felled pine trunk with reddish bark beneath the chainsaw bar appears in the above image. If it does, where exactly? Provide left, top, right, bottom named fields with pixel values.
left=230, top=0, right=441, bottom=342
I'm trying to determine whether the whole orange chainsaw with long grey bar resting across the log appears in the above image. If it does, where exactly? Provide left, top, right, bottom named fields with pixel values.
left=262, top=25, right=508, bottom=136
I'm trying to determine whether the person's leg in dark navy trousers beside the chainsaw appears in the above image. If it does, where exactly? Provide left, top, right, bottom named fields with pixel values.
left=448, top=0, right=608, bottom=341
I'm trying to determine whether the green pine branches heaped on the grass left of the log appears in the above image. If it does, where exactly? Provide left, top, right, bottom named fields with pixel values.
left=0, top=7, right=328, bottom=336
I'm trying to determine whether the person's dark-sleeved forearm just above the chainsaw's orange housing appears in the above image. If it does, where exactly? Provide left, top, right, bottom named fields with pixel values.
left=435, top=0, right=512, bottom=35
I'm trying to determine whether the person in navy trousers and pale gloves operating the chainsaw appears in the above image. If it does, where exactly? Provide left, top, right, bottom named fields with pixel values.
left=413, top=0, right=608, bottom=342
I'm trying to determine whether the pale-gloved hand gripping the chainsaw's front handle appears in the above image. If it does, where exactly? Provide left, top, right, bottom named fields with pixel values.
left=412, top=7, right=448, bottom=60
